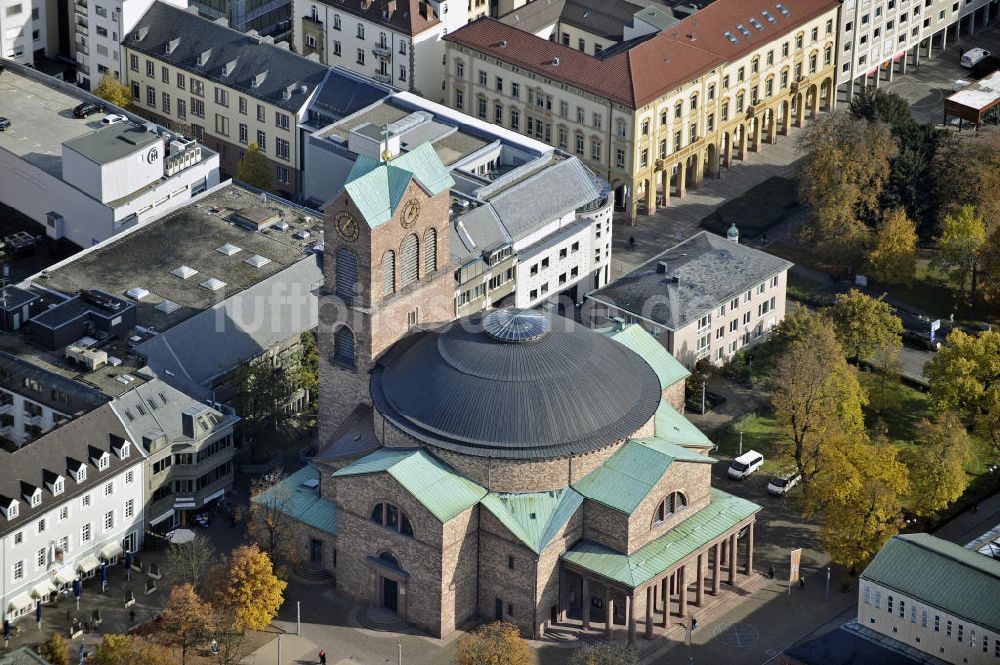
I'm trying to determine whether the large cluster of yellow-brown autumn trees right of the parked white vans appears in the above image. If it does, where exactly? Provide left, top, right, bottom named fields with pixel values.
left=768, top=291, right=970, bottom=566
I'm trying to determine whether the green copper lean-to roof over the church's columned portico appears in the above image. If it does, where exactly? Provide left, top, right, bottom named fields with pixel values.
left=562, top=488, right=760, bottom=589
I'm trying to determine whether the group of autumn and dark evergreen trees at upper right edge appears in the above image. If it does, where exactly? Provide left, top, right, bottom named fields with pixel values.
left=799, top=90, right=1000, bottom=302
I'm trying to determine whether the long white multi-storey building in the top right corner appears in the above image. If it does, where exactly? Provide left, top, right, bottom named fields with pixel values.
left=837, top=0, right=997, bottom=101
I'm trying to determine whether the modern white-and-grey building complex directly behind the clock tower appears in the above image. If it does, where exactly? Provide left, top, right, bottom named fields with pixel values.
left=305, top=92, right=613, bottom=316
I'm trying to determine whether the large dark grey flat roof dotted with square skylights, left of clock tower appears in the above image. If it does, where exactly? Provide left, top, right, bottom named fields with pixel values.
left=38, top=183, right=322, bottom=331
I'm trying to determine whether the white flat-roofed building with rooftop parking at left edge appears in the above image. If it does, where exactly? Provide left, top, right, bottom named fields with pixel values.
left=0, top=63, right=219, bottom=247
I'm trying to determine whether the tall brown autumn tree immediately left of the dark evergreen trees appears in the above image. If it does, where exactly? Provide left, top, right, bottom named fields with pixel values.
left=799, top=113, right=898, bottom=271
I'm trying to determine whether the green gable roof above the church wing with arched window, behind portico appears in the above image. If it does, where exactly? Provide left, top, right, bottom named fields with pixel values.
left=573, top=437, right=715, bottom=515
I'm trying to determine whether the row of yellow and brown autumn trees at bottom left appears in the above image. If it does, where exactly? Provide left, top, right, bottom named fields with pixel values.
left=39, top=539, right=287, bottom=665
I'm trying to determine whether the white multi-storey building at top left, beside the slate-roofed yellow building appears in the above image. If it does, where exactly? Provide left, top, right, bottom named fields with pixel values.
left=73, top=0, right=188, bottom=91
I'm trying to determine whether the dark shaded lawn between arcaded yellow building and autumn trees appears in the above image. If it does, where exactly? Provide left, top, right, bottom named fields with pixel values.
left=701, top=176, right=798, bottom=239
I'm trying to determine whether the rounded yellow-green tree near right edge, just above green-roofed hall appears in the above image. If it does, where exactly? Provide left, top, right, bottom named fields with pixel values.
left=908, top=411, right=972, bottom=515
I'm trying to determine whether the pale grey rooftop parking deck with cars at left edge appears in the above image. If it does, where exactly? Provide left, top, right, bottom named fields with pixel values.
left=0, top=67, right=104, bottom=179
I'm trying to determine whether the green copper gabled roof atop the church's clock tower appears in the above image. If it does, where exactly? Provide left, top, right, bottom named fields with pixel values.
left=344, top=143, right=455, bottom=228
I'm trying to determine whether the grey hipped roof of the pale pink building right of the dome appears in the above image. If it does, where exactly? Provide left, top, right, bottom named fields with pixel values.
left=587, top=231, right=792, bottom=330
